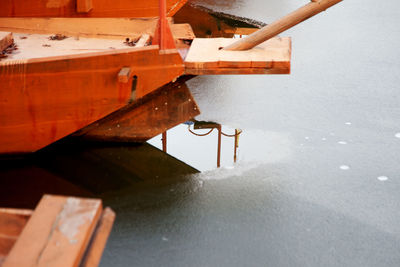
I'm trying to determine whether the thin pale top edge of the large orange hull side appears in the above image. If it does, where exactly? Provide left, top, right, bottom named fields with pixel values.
left=0, top=45, right=159, bottom=67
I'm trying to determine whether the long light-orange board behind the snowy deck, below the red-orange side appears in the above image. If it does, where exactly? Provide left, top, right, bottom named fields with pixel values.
left=0, top=17, right=194, bottom=40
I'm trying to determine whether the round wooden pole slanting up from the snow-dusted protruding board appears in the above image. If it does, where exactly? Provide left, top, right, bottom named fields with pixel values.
left=223, top=0, right=343, bottom=51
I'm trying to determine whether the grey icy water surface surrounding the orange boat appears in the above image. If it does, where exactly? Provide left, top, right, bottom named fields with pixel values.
left=101, top=0, right=400, bottom=267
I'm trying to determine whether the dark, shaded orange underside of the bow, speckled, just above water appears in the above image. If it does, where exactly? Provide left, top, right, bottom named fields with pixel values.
left=77, top=79, right=200, bottom=142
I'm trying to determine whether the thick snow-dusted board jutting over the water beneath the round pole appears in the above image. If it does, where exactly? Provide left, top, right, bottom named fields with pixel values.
left=185, top=37, right=291, bottom=75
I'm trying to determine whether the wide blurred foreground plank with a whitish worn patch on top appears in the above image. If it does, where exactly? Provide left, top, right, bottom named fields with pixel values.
left=3, top=195, right=102, bottom=267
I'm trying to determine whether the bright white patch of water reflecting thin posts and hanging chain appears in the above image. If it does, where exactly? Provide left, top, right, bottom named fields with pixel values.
left=148, top=122, right=293, bottom=175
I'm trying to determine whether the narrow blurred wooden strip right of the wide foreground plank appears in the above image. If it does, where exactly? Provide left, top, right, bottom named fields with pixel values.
left=80, top=207, right=115, bottom=267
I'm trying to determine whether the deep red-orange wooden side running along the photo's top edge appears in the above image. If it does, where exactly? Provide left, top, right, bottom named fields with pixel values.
left=0, top=0, right=187, bottom=18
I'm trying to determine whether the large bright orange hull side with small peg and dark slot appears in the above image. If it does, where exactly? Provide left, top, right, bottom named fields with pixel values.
left=0, top=46, right=184, bottom=154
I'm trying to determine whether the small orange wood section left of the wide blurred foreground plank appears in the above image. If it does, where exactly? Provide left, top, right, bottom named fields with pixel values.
left=0, top=208, right=33, bottom=266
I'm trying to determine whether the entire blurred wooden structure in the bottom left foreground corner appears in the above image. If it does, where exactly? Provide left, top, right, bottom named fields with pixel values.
left=0, top=195, right=115, bottom=267
